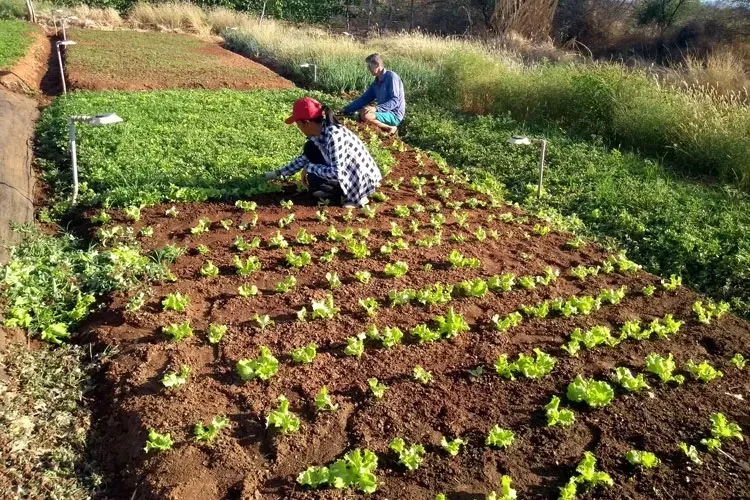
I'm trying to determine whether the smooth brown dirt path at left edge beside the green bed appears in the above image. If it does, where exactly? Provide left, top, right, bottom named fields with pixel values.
left=0, top=88, right=39, bottom=262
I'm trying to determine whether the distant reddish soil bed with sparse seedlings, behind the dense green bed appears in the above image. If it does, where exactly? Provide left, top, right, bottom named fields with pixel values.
left=66, top=29, right=294, bottom=90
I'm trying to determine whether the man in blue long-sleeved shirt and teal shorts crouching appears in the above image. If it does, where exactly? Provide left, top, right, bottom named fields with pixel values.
left=342, top=54, right=406, bottom=134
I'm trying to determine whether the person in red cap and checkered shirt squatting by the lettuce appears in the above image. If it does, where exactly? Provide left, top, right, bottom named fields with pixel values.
left=265, top=97, right=383, bottom=207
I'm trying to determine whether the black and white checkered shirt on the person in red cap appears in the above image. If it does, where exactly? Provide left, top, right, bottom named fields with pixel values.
left=278, top=124, right=383, bottom=205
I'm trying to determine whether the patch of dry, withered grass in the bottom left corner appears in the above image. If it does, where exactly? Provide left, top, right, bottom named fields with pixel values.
left=0, top=344, right=101, bottom=500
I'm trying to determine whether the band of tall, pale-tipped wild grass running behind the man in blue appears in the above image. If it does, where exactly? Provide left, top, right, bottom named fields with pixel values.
left=224, top=25, right=750, bottom=189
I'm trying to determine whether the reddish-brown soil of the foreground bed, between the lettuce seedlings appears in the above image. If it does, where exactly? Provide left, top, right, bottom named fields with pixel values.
left=79, top=140, right=750, bottom=500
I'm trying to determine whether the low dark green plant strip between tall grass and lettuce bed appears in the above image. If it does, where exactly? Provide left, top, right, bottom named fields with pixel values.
left=406, top=105, right=750, bottom=317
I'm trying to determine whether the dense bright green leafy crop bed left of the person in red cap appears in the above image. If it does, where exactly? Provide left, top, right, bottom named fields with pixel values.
left=38, top=90, right=392, bottom=206
